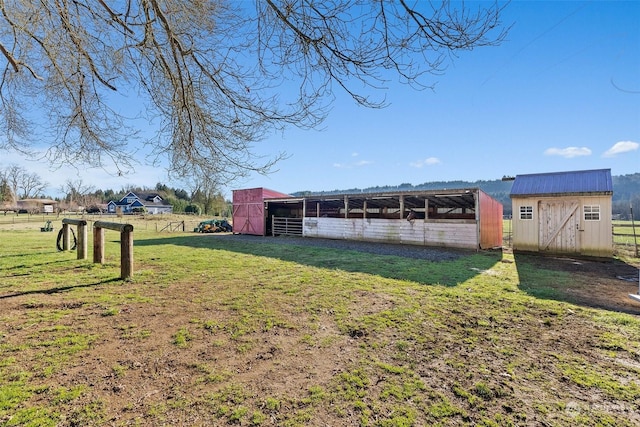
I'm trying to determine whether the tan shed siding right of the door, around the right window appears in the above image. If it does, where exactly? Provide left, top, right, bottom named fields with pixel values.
left=580, top=196, right=613, bottom=257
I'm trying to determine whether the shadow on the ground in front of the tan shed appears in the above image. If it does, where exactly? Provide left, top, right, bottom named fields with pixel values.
left=514, top=252, right=640, bottom=315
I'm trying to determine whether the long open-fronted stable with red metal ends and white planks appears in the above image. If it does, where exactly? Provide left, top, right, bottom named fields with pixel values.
left=233, top=188, right=502, bottom=249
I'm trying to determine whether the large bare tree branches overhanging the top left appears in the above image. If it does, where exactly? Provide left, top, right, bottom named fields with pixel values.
left=0, top=0, right=504, bottom=182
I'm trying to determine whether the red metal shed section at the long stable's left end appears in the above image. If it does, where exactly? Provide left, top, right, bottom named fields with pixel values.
left=232, top=188, right=289, bottom=236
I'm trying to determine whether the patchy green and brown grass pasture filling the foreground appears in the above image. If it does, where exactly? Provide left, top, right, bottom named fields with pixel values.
left=0, top=221, right=640, bottom=427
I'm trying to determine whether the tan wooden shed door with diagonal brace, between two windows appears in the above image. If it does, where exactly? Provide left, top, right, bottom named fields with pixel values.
left=538, top=200, right=580, bottom=253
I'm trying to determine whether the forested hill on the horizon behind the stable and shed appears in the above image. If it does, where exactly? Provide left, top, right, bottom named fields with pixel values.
left=293, top=173, right=640, bottom=218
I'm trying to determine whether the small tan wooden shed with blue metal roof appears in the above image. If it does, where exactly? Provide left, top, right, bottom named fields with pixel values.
left=510, top=169, right=613, bottom=257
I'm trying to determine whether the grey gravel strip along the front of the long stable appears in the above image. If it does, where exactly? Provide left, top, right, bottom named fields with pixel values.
left=229, top=234, right=474, bottom=261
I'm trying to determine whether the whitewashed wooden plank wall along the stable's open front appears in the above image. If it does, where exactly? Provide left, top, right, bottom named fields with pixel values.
left=303, top=218, right=478, bottom=249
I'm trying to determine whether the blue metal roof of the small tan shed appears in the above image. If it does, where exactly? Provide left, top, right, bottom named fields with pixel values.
left=510, top=169, right=613, bottom=197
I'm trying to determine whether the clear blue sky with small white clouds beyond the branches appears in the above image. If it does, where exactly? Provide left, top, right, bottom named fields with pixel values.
left=0, top=1, right=640, bottom=199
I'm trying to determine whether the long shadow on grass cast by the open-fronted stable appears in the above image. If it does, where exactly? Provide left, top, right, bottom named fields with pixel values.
left=135, top=234, right=502, bottom=286
